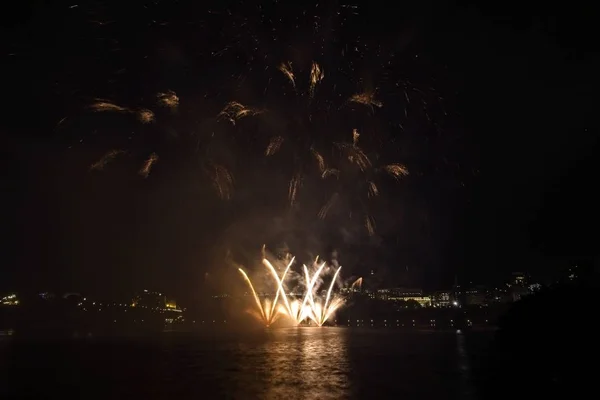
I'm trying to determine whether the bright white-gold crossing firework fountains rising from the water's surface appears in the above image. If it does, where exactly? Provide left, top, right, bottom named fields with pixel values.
left=239, top=258, right=344, bottom=327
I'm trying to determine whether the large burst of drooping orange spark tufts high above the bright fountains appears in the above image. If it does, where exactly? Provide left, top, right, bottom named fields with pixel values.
left=217, top=53, right=408, bottom=235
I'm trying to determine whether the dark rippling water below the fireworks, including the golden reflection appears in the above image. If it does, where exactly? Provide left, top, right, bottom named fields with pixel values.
left=0, top=328, right=489, bottom=400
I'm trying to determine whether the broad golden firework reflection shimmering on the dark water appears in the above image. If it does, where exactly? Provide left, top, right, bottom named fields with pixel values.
left=264, top=327, right=350, bottom=399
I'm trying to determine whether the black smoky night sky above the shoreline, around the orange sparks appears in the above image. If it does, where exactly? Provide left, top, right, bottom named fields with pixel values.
left=0, top=1, right=598, bottom=298
